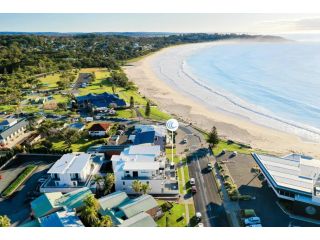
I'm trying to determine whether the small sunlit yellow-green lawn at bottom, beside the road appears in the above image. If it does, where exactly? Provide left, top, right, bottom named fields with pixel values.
left=157, top=200, right=187, bottom=227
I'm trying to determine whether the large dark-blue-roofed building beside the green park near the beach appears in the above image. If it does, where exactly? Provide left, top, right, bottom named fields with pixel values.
left=76, top=92, right=126, bottom=108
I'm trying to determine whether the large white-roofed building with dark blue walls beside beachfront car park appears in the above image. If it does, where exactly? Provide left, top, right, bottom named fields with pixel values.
left=252, top=153, right=320, bottom=219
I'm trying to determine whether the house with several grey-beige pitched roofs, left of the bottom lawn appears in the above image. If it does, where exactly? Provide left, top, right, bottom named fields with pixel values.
left=98, top=191, right=163, bottom=227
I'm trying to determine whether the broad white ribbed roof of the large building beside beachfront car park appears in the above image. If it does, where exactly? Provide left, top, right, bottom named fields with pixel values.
left=253, top=154, right=320, bottom=194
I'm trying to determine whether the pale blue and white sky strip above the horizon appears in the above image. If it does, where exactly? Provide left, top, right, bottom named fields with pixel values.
left=0, top=13, right=320, bottom=34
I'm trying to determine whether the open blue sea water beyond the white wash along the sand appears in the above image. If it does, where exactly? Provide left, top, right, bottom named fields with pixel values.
left=183, top=42, right=320, bottom=139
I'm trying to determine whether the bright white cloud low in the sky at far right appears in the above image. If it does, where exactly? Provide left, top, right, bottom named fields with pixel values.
left=256, top=16, right=320, bottom=32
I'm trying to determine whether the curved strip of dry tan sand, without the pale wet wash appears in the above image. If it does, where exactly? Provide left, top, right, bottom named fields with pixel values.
left=123, top=41, right=320, bottom=157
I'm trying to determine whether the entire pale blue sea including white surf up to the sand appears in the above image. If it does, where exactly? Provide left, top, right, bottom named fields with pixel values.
left=154, top=42, right=320, bottom=142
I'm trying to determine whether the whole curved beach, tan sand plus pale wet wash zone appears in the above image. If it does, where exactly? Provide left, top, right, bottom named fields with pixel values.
left=124, top=42, right=320, bottom=157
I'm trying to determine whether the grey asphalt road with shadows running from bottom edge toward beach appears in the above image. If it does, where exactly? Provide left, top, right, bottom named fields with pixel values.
left=177, top=126, right=228, bottom=227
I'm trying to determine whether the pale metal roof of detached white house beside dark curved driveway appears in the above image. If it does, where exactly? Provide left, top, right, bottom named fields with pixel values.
left=48, top=153, right=91, bottom=174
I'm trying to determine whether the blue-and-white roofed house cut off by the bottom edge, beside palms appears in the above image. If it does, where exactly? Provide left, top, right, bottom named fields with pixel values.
left=39, top=210, right=84, bottom=227
